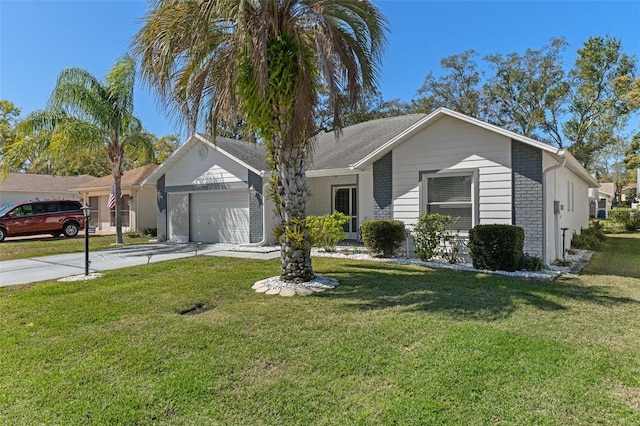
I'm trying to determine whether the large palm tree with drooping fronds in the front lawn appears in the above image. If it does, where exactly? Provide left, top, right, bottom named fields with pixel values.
left=133, top=0, right=387, bottom=282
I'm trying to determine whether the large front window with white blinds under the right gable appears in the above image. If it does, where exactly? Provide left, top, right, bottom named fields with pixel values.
left=425, top=174, right=473, bottom=231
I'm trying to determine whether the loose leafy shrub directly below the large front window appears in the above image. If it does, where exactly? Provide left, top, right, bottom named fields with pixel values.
left=412, top=213, right=459, bottom=263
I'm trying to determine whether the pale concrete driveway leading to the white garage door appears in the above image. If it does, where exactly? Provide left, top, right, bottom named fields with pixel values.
left=0, top=243, right=280, bottom=287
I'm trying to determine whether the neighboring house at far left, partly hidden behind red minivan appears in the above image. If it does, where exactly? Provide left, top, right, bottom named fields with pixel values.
left=0, top=173, right=95, bottom=206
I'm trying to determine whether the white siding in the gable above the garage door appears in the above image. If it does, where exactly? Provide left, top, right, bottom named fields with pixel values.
left=166, top=143, right=248, bottom=186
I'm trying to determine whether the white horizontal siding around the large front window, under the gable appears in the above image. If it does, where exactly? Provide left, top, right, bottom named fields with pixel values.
left=393, top=113, right=512, bottom=224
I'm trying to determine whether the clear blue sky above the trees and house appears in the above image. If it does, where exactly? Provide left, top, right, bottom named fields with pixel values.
left=0, top=0, right=640, bottom=136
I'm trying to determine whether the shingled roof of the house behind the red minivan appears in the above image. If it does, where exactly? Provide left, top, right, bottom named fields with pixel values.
left=0, top=173, right=95, bottom=192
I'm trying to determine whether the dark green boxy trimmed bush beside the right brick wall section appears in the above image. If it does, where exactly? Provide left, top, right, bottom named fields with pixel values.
left=469, top=225, right=524, bottom=271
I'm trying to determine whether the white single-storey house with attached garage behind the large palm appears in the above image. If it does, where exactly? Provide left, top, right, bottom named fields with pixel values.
left=143, top=108, right=598, bottom=263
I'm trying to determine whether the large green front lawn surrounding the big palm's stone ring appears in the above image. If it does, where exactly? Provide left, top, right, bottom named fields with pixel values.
left=0, top=238, right=640, bottom=425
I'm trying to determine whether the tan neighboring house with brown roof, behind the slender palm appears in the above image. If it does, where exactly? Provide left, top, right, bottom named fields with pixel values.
left=74, top=164, right=158, bottom=231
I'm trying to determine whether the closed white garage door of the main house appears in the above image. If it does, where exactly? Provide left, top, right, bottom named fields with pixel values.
left=189, top=190, right=249, bottom=244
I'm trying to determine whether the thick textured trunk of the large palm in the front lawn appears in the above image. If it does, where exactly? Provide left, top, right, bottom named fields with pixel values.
left=273, top=140, right=314, bottom=283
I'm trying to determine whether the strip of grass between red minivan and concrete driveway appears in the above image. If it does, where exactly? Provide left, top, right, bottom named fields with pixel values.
left=0, top=235, right=149, bottom=261
